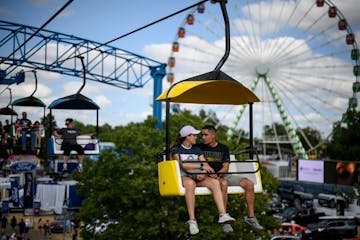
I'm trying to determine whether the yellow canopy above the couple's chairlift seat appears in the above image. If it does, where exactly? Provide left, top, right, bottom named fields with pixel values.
left=156, top=71, right=260, bottom=105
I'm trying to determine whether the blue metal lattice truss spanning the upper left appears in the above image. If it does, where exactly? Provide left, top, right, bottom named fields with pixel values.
left=0, top=21, right=166, bottom=89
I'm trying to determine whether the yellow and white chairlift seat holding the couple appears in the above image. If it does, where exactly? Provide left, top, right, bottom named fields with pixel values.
left=158, top=155, right=262, bottom=196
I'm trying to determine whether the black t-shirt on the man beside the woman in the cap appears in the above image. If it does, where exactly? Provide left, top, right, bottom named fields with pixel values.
left=198, top=143, right=230, bottom=172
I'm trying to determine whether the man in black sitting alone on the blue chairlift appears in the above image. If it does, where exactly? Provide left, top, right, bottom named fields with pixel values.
left=53, top=118, right=84, bottom=172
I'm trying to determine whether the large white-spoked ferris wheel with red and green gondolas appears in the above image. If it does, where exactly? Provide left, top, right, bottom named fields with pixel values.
left=167, top=0, right=360, bottom=158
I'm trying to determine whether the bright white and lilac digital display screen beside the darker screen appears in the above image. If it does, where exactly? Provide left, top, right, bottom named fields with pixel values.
left=298, top=159, right=324, bottom=183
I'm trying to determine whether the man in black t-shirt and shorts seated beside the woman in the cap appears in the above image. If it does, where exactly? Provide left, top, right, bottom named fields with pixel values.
left=199, top=125, right=264, bottom=232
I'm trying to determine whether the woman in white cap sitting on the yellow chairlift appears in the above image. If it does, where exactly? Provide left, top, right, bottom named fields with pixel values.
left=171, top=125, right=235, bottom=235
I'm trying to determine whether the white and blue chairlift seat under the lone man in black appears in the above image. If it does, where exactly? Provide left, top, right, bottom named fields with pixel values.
left=51, top=135, right=99, bottom=155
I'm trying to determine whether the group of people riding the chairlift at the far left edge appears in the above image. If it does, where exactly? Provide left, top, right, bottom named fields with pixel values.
left=0, top=112, right=44, bottom=156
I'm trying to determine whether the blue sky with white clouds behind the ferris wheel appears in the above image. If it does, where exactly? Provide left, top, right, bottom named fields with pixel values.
left=0, top=0, right=360, bottom=140
